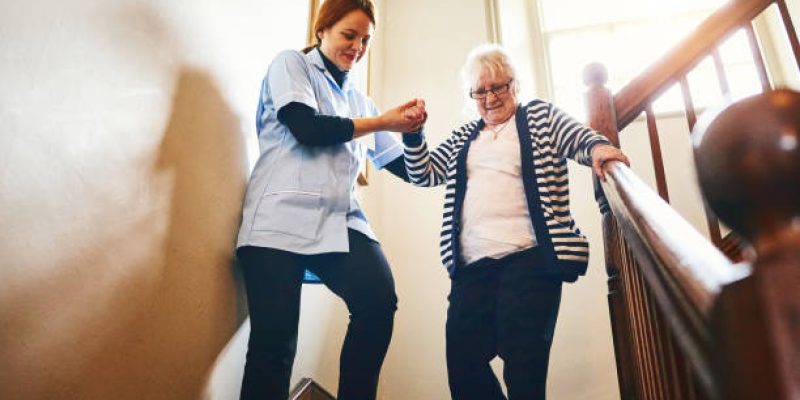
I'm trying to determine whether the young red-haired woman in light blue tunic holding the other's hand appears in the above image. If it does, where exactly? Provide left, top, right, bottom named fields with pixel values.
left=237, top=0, right=425, bottom=400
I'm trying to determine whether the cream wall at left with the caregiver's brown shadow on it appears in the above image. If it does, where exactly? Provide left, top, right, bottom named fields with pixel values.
left=0, top=0, right=322, bottom=399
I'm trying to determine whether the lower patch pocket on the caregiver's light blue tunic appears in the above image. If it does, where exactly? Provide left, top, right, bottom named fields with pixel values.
left=253, top=190, right=323, bottom=239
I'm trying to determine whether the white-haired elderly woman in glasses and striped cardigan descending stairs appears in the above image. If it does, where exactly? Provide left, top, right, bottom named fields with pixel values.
left=403, top=45, right=627, bottom=400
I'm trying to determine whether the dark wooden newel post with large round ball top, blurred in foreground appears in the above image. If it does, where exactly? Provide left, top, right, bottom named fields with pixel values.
left=695, top=90, right=800, bottom=399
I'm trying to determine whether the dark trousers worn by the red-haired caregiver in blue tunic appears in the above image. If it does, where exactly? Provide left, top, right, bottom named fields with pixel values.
left=237, top=230, right=397, bottom=400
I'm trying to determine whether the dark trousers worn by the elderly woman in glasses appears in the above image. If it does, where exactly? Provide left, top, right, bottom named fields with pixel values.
left=446, top=248, right=562, bottom=400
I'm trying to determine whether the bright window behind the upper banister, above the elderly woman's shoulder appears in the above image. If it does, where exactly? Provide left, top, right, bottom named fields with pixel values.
left=499, top=0, right=760, bottom=119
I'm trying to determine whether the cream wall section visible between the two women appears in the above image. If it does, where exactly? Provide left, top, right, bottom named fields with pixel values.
left=365, top=0, right=486, bottom=400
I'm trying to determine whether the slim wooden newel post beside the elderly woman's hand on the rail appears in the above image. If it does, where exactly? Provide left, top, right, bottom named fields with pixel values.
left=583, top=63, right=641, bottom=400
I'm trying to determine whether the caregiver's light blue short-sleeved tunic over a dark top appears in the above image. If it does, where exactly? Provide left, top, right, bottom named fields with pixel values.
left=237, top=49, right=403, bottom=260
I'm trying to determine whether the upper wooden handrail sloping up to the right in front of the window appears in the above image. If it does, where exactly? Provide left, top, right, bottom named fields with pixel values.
left=614, top=0, right=774, bottom=130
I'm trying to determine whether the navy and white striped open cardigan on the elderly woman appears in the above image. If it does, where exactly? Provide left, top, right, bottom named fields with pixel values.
left=403, top=100, right=610, bottom=281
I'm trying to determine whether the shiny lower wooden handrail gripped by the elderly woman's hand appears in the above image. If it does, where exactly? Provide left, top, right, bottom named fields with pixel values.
left=602, top=162, right=750, bottom=398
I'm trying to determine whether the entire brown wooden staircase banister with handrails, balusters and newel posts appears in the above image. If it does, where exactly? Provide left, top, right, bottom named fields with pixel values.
left=584, top=0, right=800, bottom=399
